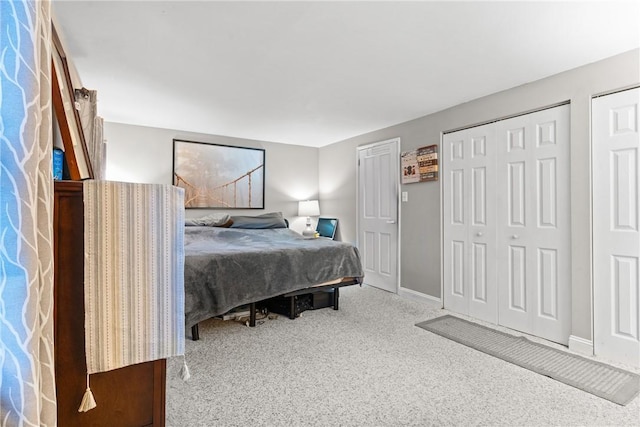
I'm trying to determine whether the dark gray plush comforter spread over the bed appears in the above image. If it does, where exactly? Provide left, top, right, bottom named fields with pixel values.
left=184, top=226, right=364, bottom=328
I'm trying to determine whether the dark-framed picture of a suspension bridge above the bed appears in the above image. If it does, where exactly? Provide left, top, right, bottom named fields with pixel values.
left=173, top=139, right=265, bottom=209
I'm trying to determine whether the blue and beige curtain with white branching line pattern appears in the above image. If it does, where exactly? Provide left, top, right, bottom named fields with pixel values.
left=0, top=0, right=56, bottom=426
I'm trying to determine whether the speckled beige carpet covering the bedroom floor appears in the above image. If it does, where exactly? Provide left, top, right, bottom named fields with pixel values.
left=167, top=286, right=640, bottom=427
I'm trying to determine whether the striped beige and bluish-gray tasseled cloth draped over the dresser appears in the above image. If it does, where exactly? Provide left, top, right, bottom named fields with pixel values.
left=83, top=180, right=185, bottom=374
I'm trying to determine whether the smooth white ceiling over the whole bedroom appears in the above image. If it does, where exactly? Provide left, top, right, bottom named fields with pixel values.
left=53, top=0, right=640, bottom=146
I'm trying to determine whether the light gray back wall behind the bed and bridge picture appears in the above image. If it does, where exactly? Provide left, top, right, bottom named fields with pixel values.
left=104, top=122, right=322, bottom=231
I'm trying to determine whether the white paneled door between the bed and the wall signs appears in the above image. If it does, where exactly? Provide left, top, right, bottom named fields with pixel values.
left=358, top=139, right=400, bottom=293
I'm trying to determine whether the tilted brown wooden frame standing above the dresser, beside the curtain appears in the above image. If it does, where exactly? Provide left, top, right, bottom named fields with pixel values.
left=51, top=27, right=93, bottom=181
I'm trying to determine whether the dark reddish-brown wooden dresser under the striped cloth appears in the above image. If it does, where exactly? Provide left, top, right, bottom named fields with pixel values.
left=53, top=181, right=166, bottom=427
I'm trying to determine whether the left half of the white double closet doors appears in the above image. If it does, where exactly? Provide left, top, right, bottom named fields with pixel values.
left=442, top=125, right=498, bottom=323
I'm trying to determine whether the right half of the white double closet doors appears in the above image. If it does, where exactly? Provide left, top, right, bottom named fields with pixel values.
left=497, top=105, right=571, bottom=344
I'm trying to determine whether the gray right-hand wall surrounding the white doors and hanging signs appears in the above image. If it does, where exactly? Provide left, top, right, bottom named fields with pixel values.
left=319, top=50, right=640, bottom=340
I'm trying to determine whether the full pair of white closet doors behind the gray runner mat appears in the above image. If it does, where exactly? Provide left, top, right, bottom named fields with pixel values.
left=442, top=106, right=571, bottom=344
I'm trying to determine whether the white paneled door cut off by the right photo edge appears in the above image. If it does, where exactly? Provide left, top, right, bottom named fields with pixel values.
left=592, top=89, right=640, bottom=367
